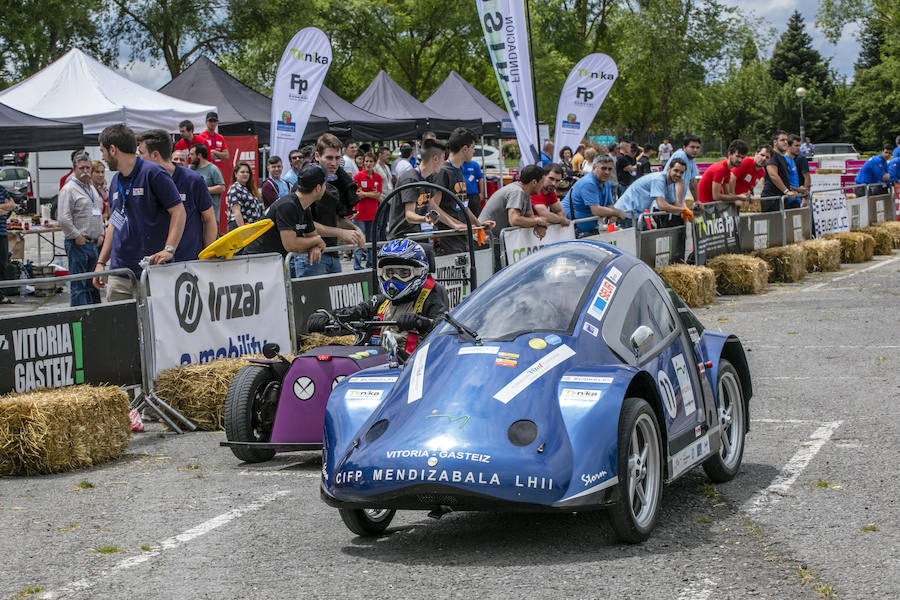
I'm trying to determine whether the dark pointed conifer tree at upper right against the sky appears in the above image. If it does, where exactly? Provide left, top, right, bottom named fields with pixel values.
left=769, top=11, right=834, bottom=94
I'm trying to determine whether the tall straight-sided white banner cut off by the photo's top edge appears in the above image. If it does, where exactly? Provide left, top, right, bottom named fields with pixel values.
left=475, top=0, right=541, bottom=165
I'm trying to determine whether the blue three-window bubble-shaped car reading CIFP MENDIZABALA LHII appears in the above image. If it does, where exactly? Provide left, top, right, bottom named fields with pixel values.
left=321, top=240, right=752, bottom=543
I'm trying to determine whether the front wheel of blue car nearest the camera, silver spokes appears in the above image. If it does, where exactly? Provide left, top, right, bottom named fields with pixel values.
left=610, top=398, right=663, bottom=544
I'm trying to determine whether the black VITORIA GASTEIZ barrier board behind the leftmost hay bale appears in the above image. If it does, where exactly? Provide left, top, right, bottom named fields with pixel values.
left=0, top=302, right=141, bottom=394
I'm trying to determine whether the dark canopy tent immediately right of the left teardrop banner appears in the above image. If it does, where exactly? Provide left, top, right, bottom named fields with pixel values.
left=313, top=85, right=416, bottom=141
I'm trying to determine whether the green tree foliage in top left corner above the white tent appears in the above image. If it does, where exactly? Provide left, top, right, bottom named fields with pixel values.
left=0, top=0, right=114, bottom=88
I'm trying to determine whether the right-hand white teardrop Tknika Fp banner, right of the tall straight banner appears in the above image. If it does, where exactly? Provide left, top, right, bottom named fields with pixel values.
left=554, top=54, right=619, bottom=159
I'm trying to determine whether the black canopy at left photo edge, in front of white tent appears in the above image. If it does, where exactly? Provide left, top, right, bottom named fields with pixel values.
left=0, top=103, right=85, bottom=152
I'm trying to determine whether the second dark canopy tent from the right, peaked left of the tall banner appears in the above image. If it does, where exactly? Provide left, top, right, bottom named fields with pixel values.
left=353, top=71, right=481, bottom=135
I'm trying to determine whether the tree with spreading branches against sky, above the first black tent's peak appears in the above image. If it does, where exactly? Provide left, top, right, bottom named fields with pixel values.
left=110, top=0, right=233, bottom=78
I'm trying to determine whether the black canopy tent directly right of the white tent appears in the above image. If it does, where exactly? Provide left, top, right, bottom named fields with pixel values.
left=159, top=56, right=328, bottom=144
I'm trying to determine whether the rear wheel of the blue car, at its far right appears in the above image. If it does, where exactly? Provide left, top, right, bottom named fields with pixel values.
left=703, top=358, right=747, bottom=483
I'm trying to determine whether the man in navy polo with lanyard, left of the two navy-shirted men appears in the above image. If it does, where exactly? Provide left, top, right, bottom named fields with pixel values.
left=94, top=125, right=185, bottom=302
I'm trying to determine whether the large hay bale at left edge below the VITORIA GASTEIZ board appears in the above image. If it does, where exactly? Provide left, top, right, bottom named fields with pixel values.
left=0, top=385, right=131, bottom=475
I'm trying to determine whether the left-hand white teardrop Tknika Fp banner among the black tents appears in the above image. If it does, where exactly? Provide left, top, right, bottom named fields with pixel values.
left=269, top=27, right=331, bottom=159
